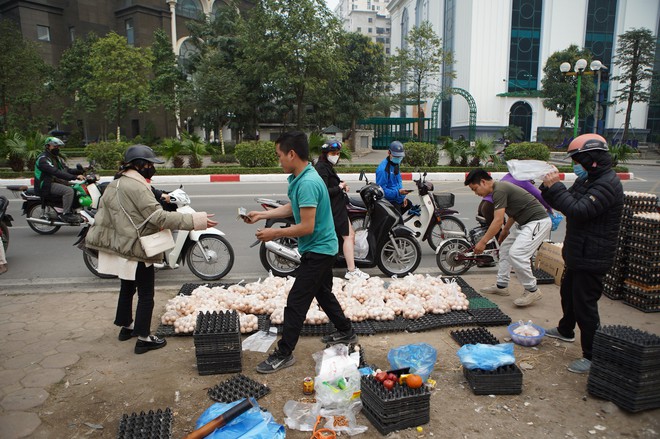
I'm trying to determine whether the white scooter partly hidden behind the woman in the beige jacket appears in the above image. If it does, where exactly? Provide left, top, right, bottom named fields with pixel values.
left=74, top=187, right=234, bottom=281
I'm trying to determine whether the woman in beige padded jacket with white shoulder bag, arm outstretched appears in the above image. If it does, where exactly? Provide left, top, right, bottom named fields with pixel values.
left=85, top=145, right=217, bottom=354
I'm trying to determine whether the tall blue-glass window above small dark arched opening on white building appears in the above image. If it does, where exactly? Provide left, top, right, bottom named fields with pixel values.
left=508, top=0, right=543, bottom=92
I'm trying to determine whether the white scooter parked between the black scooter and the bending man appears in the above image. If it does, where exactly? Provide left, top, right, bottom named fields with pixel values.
left=403, top=172, right=467, bottom=251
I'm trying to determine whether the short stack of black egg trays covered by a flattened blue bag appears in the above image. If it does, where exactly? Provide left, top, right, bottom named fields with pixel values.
left=463, top=364, right=522, bottom=395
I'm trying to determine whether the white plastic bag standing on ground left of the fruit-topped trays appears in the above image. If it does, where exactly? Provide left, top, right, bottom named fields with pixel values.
left=312, top=344, right=360, bottom=408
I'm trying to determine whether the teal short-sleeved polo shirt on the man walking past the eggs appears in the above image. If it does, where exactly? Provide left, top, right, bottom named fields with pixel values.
left=287, top=164, right=339, bottom=256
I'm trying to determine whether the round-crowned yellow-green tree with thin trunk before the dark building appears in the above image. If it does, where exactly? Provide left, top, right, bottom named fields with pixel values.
left=85, top=32, right=152, bottom=141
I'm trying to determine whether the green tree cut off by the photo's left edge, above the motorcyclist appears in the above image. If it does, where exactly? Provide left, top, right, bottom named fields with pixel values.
left=0, top=19, right=51, bottom=132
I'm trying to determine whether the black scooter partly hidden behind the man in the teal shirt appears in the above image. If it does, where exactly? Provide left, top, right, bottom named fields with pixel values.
left=253, top=172, right=422, bottom=276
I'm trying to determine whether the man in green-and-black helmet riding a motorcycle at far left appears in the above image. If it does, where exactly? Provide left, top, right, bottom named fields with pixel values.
left=34, top=137, right=85, bottom=223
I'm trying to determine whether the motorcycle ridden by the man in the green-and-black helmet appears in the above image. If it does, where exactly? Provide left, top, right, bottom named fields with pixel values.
left=7, top=163, right=108, bottom=235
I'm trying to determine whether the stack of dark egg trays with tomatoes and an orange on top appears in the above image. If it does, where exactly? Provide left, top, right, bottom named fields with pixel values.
left=360, top=375, right=431, bottom=435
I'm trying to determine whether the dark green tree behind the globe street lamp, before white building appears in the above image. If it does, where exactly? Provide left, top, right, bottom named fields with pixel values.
left=541, top=45, right=596, bottom=136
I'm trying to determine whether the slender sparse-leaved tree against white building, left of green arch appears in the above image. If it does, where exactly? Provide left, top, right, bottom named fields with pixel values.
left=392, top=21, right=456, bottom=139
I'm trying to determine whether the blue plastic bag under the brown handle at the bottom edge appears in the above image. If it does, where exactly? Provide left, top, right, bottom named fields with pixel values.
left=195, top=398, right=286, bottom=439
